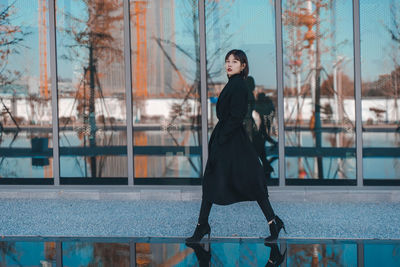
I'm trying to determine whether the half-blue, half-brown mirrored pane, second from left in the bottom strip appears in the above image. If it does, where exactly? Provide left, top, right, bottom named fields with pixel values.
left=62, top=242, right=130, bottom=267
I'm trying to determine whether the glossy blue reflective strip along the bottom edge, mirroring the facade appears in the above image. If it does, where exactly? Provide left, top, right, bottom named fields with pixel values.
left=0, top=237, right=400, bottom=267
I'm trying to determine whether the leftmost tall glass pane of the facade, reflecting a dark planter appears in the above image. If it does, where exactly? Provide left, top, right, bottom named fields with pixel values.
left=0, top=0, right=53, bottom=178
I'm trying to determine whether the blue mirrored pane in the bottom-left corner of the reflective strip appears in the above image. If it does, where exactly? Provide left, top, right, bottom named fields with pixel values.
left=0, top=241, right=56, bottom=266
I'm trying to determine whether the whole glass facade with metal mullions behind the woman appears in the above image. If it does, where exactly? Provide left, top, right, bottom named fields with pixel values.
left=0, top=0, right=400, bottom=186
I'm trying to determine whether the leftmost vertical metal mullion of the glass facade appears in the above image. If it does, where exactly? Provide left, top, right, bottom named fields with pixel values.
left=48, top=0, right=60, bottom=186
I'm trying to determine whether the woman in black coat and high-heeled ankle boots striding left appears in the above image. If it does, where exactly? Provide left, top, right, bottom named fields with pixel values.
left=186, top=50, right=286, bottom=243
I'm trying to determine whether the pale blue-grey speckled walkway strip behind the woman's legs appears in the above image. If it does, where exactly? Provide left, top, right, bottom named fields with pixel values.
left=0, top=198, right=400, bottom=240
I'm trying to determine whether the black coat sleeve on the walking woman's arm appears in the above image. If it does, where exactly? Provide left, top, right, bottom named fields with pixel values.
left=218, top=86, right=248, bottom=144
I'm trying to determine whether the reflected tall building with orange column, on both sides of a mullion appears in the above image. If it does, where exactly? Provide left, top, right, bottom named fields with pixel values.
left=89, top=0, right=179, bottom=97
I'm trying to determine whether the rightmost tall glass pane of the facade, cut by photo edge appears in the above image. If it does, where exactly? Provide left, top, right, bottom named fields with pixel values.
left=360, top=0, right=400, bottom=179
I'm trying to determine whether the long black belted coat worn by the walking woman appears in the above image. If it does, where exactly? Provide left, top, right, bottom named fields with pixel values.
left=203, top=74, right=268, bottom=205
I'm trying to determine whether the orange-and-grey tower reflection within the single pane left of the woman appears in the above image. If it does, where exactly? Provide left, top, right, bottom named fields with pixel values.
left=131, top=0, right=176, bottom=96
